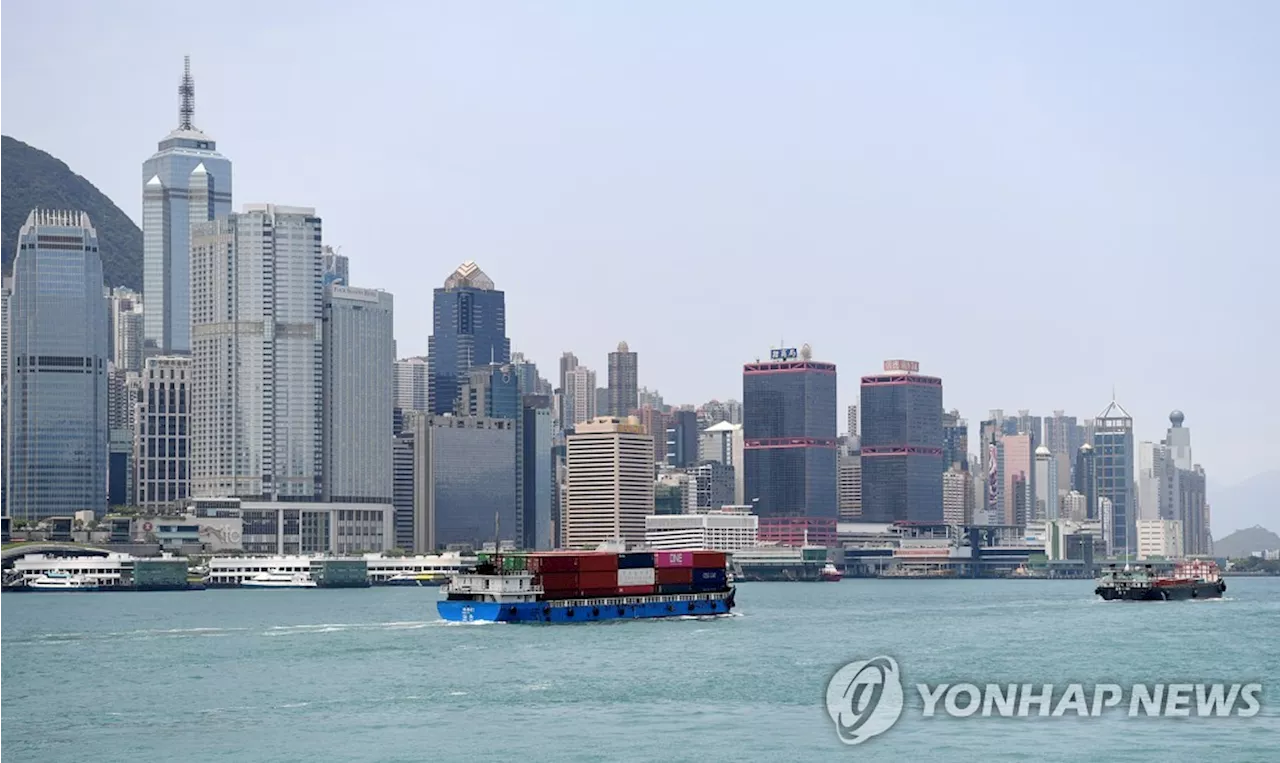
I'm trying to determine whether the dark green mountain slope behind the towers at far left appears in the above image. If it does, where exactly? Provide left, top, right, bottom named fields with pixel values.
left=0, top=136, right=142, bottom=291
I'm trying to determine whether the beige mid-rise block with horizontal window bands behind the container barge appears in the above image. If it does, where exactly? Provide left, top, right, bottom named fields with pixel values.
left=562, top=416, right=654, bottom=548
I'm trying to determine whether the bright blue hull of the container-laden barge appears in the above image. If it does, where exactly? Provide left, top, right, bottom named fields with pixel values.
left=435, top=590, right=735, bottom=623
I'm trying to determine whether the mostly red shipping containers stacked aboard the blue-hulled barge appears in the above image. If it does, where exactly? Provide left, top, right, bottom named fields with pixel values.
left=494, top=550, right=727, bottom=599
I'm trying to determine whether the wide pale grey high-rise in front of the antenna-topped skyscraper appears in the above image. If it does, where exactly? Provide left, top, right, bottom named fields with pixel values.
left=191, top=205, right=324, bottom=501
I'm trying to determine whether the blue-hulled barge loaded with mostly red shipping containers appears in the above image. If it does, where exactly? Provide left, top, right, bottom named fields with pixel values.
left=436, top=550, right=735, bottom=623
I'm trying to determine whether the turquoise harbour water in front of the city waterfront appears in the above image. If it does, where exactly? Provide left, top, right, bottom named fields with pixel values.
left=0, top=579, right=1280, bottom=763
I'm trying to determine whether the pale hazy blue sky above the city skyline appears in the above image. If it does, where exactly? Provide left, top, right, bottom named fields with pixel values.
left=0, top=0, right=1280, bottom=498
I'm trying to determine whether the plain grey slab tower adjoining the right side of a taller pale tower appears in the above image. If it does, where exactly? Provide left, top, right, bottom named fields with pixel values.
left=322, top=282, right=396, bottom=503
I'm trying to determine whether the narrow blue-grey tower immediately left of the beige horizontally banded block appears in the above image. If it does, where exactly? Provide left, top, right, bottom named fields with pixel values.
left=520, top=394, right=557, bottom=550
